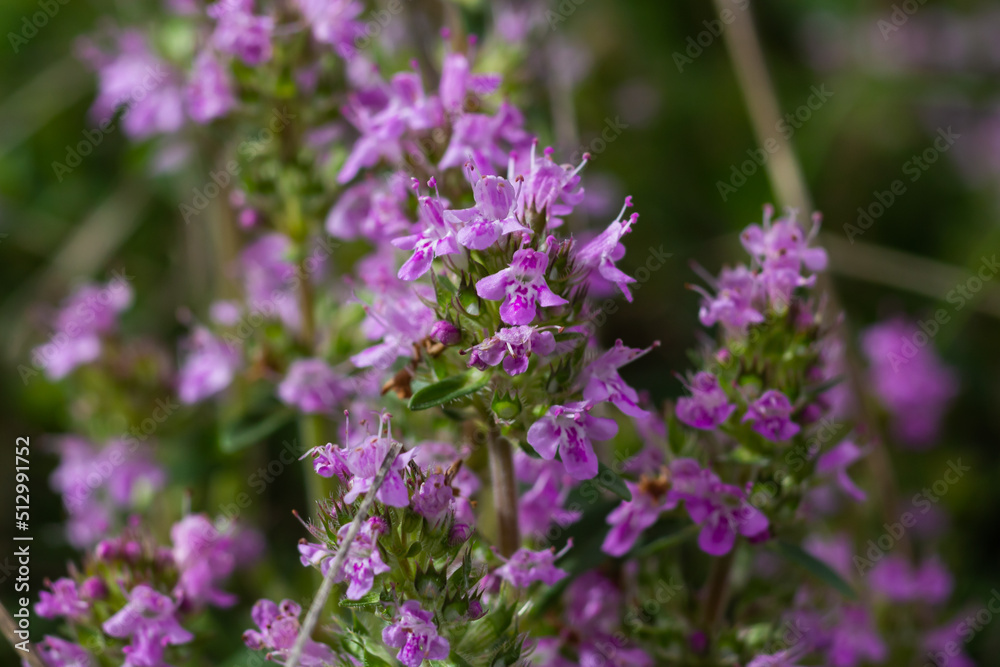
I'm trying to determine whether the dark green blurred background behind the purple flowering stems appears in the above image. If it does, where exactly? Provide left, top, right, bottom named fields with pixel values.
left=0, top=0, right=1000, bottom=665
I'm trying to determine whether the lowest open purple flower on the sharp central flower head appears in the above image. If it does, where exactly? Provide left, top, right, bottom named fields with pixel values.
left=528, top=402, right=618, bottom=480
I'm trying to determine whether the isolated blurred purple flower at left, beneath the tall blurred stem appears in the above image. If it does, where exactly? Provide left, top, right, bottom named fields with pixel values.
left=177, top=327, right=242, bottom=403
